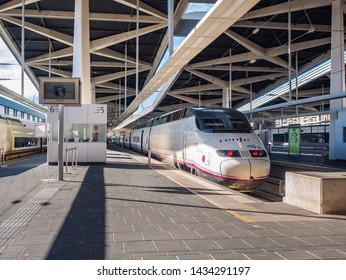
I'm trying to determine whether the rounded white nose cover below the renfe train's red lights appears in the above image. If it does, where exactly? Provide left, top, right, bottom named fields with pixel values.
left=220, top=159, right=270, bottom=182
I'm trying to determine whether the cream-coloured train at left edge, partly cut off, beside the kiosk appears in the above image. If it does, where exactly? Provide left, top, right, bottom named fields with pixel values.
left=0, top=115, right=47, bottom=162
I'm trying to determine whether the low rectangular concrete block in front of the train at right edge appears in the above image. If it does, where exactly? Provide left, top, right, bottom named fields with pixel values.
left=283, top=171, right=346, bottom=214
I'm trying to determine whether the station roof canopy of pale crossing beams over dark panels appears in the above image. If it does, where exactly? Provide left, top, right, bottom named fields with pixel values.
left=0, top=0, right=346, bottom=128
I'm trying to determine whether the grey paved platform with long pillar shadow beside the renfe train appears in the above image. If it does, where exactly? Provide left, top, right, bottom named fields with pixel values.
left=0, top=145, right=346, bottom=260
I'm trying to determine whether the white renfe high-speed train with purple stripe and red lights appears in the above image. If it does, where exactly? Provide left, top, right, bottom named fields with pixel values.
left=118, top=108, right=270, bottom=191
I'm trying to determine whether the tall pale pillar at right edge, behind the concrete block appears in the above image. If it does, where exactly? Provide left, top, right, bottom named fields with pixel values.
left=329, top=0, right=346, bottom=160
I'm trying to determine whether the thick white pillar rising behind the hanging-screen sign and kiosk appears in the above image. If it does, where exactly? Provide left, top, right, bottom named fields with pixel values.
left=72, top=0, right=93, bottom=104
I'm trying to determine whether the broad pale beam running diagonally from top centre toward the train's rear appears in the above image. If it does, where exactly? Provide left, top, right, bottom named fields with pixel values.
left=117, top=0, right=259, bottom=126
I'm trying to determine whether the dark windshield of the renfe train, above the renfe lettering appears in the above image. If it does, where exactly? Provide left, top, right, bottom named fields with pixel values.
left=196, top=113, right=252, bottom=133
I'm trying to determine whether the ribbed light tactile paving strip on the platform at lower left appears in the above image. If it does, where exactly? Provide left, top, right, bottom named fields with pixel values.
left=0, top=188, right=58, bottom=246
